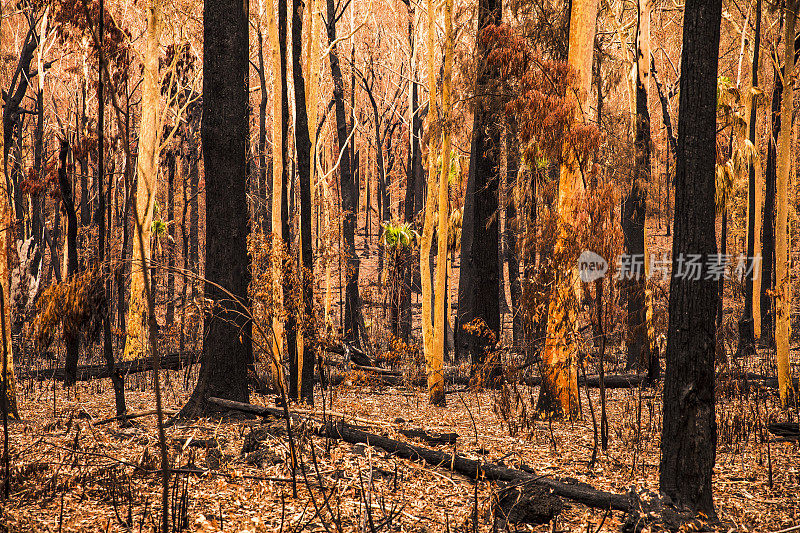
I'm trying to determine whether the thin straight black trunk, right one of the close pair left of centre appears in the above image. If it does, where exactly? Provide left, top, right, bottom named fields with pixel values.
left=292, top=0, right=317, bottom=405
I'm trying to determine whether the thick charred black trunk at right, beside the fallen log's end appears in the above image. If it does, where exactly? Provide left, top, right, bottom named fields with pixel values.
left=659, top=0, right=722, bottom=518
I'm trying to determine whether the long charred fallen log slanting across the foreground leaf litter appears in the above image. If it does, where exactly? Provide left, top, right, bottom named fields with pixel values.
left=208, top=398, right=633, bottom=512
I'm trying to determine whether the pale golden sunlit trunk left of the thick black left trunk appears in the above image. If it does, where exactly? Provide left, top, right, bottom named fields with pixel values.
left=123, top=0, right=163, bottom=361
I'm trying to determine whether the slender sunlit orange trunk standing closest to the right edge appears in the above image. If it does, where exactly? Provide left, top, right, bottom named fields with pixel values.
left=775, top=0, right=799, bottom=407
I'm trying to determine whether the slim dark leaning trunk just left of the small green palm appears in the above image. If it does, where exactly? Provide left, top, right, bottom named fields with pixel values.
left=326, top=0, right=360, bottom=347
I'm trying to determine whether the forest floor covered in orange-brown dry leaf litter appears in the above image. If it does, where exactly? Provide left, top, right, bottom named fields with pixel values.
left=0, top=358, right=800, bottom=533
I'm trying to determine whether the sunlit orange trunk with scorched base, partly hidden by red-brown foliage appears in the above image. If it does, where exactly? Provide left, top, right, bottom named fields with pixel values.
left=538, top=0, right=598, bottom=417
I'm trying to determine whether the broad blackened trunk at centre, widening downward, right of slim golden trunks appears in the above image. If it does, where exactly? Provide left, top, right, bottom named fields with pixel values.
left=456, top=0, right=502, bottom=377
